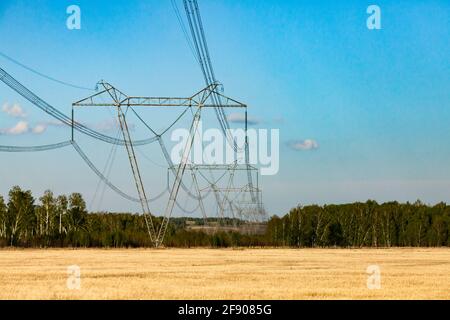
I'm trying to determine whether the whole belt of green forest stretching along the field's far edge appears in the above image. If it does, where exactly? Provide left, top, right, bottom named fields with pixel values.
left=0, top=186, right=450, bottom=248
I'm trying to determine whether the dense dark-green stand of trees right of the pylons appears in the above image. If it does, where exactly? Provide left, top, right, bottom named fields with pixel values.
left=267, top=201, right=450, bottom=247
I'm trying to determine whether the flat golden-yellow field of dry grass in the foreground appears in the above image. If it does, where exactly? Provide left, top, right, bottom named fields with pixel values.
left=0, top=249, right=450, bottom=299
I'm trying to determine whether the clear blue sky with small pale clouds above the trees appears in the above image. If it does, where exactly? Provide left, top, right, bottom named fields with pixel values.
left=0, top=0, right=450, bottom=214
